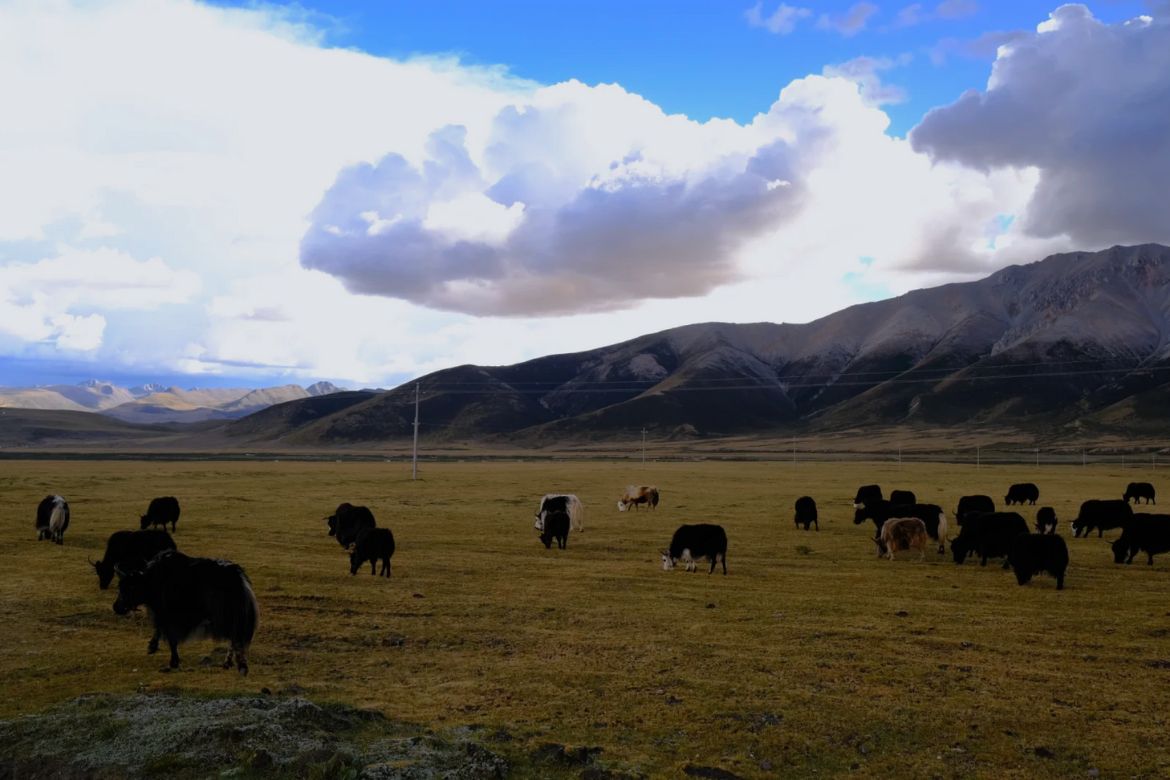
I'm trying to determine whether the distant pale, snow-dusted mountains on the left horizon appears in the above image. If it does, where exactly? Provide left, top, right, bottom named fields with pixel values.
left=0, top=380, right=339, bottom=423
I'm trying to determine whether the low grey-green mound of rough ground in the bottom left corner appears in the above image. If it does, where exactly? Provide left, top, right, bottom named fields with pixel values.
left=0, top=693, right=508, bottom=780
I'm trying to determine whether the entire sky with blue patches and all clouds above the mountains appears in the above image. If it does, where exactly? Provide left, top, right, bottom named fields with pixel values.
left=0, top=0, right=1170, bottom=387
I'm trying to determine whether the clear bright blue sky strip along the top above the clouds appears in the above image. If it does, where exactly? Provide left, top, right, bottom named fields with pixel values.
left=215, top=0, right=1148, bottom=134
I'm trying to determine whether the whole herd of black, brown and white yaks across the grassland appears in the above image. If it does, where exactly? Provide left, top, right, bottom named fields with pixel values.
left=25, top=482, right=1170, bottom=675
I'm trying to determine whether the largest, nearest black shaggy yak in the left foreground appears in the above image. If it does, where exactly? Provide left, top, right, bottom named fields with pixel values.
left=113, top=550, right=260, bottom=675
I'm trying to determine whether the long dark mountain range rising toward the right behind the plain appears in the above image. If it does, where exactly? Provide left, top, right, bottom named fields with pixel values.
left=225, top=244, right=1170, bottom=444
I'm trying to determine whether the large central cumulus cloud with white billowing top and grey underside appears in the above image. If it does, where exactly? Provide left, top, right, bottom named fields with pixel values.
left=301, top=83, right=828, bottom=316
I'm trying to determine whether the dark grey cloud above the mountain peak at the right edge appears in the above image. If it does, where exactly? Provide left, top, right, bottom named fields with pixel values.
left=911, top=5, right=1170, bottom=248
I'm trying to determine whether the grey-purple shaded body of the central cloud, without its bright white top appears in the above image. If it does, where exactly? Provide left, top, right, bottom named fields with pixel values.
left=301, top=117, right=801, bottom=316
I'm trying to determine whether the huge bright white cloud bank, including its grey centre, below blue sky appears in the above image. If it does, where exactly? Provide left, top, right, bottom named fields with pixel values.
left=0, top=0, right=1076, bottom=384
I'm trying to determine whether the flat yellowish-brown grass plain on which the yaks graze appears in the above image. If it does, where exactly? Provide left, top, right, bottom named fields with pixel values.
left=0, top=461, right=1170, bottom=778
